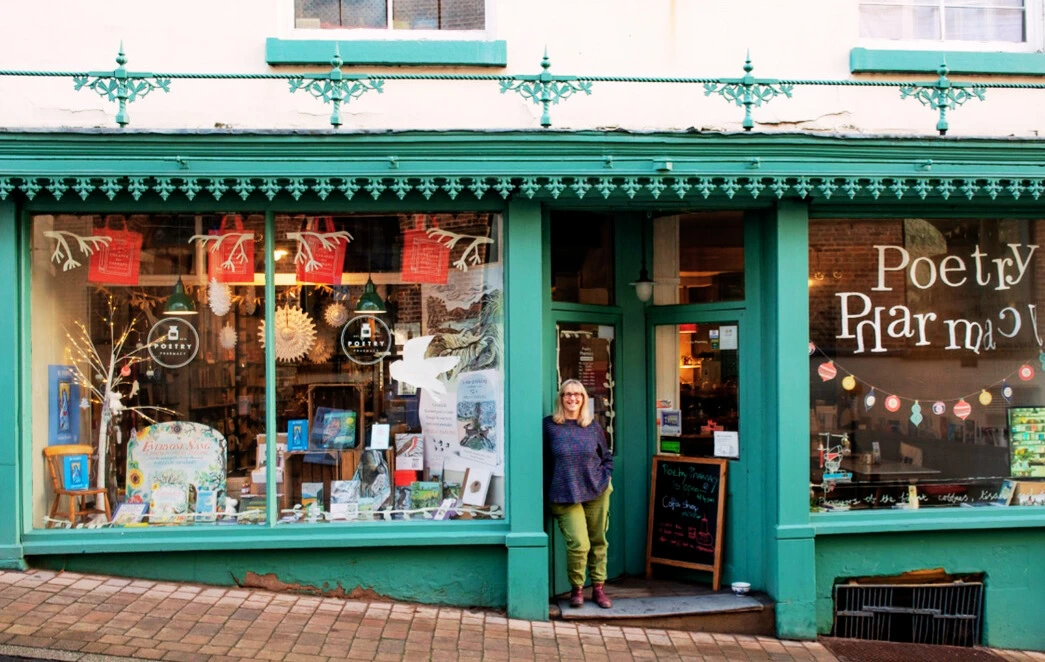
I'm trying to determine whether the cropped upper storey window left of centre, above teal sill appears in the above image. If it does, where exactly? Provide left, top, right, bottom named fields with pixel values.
left=294, top=0, right=487, bottom=30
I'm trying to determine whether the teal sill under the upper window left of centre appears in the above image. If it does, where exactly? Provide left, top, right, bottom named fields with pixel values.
left=264, top=37, right=508, bottom=67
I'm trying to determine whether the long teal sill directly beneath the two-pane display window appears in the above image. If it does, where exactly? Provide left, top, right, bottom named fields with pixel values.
left=22, top=522, right=508, bottom=556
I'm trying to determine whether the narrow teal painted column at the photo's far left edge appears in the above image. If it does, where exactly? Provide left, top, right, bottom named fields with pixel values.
left=0, top=200, right=30, bottom=570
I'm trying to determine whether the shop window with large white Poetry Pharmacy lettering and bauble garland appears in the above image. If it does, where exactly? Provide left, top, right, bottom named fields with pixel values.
left=809, top=219, right=1045, bottom=510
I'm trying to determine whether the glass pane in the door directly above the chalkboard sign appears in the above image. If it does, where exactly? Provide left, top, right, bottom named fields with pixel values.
left=653, top=321, right=740, bottom=457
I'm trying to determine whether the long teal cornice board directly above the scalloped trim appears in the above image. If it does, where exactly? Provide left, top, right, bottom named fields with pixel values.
left=0, top=130, right=1045, bottom=180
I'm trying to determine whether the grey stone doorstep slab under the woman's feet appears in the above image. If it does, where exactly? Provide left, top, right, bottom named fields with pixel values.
left=558, top=590, right=762, bottom=620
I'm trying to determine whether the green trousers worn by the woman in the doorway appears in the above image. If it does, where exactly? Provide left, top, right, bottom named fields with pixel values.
left=552, top=483, right=613, bottom=587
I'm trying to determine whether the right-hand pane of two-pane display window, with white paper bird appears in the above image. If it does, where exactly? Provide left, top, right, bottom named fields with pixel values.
left=275, top=213, right=505, bottom=524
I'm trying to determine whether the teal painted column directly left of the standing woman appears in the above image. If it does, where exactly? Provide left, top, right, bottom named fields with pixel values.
left=505, top=200, right=549, bottom=620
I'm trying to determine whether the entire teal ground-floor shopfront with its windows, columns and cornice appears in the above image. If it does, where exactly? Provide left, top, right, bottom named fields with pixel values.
left=0, top=131, right=1045, bottom=649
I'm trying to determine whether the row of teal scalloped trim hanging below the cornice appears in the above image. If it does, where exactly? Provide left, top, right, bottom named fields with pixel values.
left=6, top=173, right=1045, bottom=202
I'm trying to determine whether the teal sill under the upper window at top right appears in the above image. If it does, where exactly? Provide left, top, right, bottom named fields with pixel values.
left=850, top=48, right=1045, bottom=76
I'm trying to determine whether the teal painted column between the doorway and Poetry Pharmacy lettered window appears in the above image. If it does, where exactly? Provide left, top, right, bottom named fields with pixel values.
left=764, top=201, right=816, bottom=639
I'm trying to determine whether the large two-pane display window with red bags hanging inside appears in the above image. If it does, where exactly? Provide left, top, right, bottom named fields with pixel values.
left=29, top=213, right=505, bottom=528
